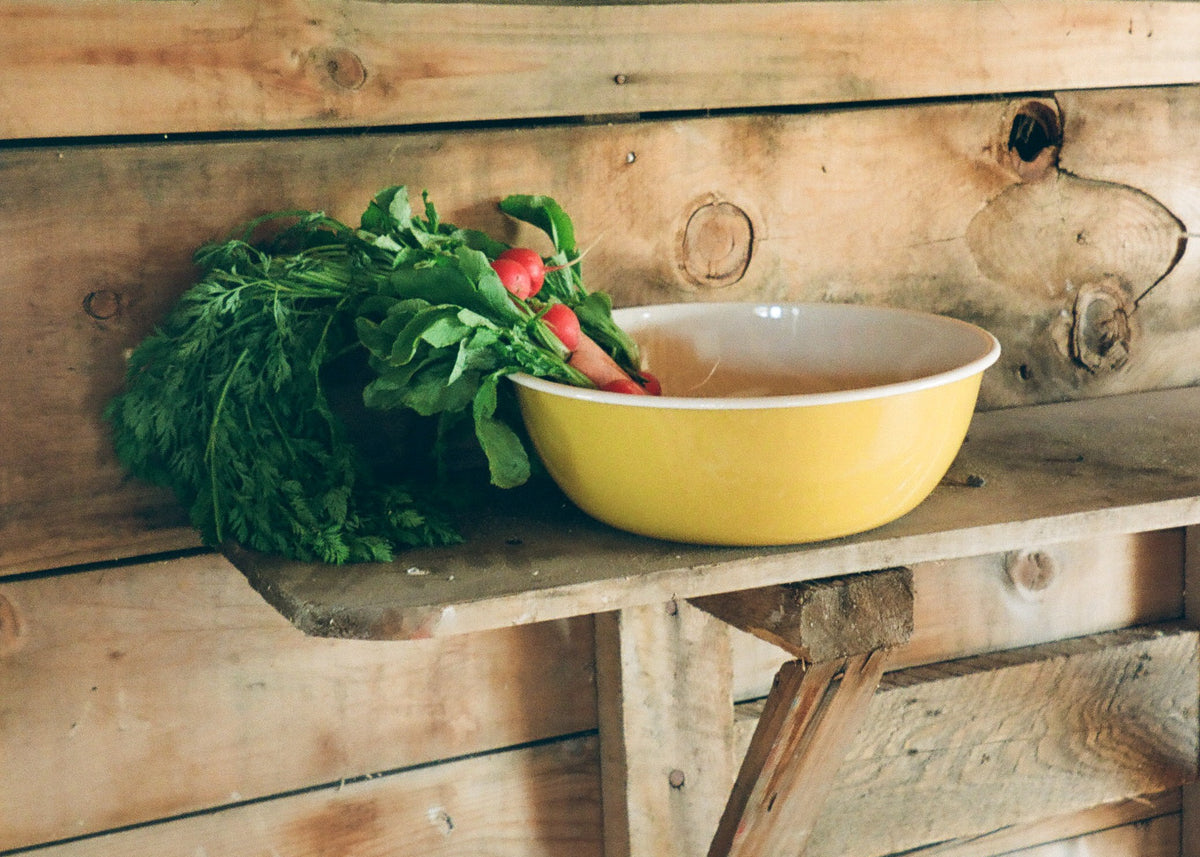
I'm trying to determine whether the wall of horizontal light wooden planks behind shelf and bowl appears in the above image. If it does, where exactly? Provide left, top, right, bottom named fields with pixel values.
left=0, top=0, right=1200, bottom=857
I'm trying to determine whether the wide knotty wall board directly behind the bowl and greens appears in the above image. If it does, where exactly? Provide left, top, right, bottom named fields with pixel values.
left=9, top=85, right=1200, bottom=573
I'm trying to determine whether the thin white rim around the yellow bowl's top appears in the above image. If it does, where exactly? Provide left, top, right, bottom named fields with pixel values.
left=509, top=301, right=1000, bottom=410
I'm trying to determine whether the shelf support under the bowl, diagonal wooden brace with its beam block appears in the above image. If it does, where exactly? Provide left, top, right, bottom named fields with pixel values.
left=692, top=569, right=913, bottom=857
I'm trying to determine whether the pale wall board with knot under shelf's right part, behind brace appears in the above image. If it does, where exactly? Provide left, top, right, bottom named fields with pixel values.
left=731, top=529, right=1193, bottom=700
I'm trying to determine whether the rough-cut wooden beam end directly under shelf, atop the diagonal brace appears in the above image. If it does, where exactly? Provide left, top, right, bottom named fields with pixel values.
left=691, top=568, right=913, bottom=664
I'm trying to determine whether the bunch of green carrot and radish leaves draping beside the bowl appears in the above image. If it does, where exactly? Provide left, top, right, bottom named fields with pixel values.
left=106, top=186, right=637, bottom=563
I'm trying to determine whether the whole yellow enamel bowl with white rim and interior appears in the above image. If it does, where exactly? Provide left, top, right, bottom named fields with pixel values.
left=512, top=304, right=1000, bottom=545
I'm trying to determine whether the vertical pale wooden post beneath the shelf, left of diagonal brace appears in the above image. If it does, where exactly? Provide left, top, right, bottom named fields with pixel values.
left=595, top=601, right=737, bottom=857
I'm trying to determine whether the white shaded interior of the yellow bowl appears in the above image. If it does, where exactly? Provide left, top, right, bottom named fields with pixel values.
left=614, top=304, right=998, bottom=400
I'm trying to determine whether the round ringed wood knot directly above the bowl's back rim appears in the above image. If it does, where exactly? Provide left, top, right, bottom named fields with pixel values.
left=680, top=200, right=754, bottom=288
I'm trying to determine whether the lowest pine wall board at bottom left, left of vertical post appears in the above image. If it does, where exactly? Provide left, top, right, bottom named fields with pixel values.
left=18, top=737, right=601, bottom=857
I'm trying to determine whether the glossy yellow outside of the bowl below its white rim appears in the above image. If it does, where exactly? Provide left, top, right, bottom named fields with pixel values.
left=517, top=373, right=982, bottom=545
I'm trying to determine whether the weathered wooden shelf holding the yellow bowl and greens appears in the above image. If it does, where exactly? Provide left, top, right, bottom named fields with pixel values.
left=227, top=388, right=1200, bottom=640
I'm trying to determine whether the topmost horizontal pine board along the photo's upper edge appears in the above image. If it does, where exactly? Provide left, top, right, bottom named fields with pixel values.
left=7, top=0, right=1200, bottom=138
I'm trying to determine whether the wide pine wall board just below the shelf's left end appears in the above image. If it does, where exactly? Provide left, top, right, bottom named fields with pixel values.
left=0, top=556, right=596, bottom=853
